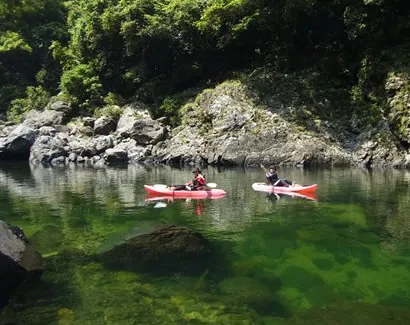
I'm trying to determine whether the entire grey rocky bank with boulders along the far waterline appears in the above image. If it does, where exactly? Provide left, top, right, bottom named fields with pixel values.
left=0, top=74, right=410, bottom=168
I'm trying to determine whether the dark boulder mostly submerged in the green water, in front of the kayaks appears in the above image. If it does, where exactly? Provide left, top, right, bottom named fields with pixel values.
left=102, top=225, right=211, bottom=274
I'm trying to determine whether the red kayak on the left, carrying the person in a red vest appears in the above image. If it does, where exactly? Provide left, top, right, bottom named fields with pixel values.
left=144, top=184, right=226, bottom=199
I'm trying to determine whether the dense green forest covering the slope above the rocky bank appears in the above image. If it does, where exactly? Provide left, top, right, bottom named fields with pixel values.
left=0, top=0, right=410, bottom=125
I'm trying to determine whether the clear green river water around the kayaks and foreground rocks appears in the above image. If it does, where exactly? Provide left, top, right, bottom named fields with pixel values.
left=0, top=166, right=410, bottom=325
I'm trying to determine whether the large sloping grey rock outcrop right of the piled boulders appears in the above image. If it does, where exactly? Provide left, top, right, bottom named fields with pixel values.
left=152, top=82, right=410, bottom=167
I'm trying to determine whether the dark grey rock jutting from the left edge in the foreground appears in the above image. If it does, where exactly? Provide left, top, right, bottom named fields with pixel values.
left=0, top=221, right=44, bottom=307
